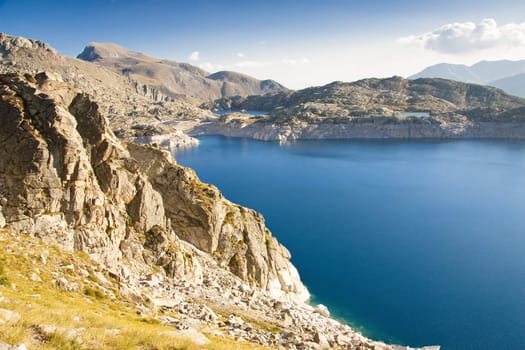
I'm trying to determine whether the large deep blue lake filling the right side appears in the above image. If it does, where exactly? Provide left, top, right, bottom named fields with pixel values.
left=175, top=136, right=525, bottom=350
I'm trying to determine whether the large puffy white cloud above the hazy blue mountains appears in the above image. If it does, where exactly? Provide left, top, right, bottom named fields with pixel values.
left=398, top=18, right=525, bottom=54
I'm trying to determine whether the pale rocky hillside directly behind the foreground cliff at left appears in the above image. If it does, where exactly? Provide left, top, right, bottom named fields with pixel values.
left=0, top=33, right=213, bottom=147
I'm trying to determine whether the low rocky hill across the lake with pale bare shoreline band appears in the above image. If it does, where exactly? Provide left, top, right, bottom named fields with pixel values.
left=195, top=77, right=525, bottom=142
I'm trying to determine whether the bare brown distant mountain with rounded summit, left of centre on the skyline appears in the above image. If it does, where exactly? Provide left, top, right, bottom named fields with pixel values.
left=77, top=43, right=287, bottom=100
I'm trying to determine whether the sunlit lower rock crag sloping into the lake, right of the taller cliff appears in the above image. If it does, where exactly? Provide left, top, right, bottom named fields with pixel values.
left=128, top=144, right=308, bottom=300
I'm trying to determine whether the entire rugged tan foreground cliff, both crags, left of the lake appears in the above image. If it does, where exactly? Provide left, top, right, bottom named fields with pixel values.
left=0, top=74, right=308, bottom=300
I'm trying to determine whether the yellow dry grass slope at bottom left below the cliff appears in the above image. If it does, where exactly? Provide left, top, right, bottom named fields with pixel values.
left=0, top=230, right=263, bottom=350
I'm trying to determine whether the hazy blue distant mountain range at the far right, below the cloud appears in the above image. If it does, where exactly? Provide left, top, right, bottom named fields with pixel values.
left=409, top=60, right=525, bottom=97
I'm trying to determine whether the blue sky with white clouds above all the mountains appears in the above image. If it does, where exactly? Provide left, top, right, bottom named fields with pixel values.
left=0, top=0, right=525, bottom=89
